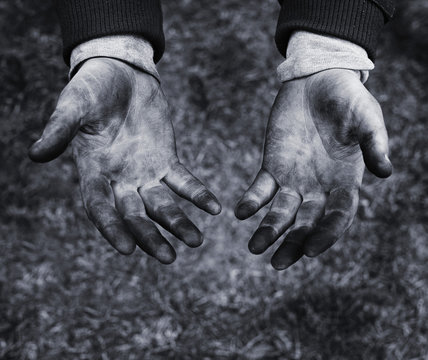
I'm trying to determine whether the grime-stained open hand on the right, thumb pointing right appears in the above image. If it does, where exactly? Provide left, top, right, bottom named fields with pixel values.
left=235, top=69, right=392, bottom=270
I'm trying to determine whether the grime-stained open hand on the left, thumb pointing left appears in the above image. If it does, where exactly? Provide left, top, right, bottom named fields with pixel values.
left=29, top=58, right=221, bottom=264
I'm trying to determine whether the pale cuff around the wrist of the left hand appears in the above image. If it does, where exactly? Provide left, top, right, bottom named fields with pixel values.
left=69, top=35, right=160, bottom=82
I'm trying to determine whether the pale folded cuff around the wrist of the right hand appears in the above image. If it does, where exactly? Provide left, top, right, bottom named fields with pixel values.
left=277, top=31, right=374, bottom=84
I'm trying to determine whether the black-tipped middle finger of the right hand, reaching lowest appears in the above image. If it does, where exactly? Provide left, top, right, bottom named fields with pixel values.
left=271, top=194, right=326, bottom=270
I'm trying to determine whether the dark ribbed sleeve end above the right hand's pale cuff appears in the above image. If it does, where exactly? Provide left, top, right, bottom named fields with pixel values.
left=275, top=0, right=394, bottom=60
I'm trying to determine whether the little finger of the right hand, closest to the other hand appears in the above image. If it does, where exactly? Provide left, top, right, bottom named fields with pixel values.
left=235, top=169, right=278, bottom=220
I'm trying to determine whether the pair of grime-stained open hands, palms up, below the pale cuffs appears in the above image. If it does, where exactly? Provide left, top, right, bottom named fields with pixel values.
left=30, top=58, right=392, bottom=270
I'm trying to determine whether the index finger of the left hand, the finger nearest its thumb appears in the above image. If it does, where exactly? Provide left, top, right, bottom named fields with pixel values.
left=80, top=177, right=135, bottom=255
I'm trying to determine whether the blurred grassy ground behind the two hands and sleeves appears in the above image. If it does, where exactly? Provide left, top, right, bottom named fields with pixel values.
left=0, top=0, right=428, bottom=360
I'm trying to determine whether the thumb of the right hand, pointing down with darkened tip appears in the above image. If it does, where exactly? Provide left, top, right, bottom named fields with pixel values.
left=354, top=95, right=392, bottom=178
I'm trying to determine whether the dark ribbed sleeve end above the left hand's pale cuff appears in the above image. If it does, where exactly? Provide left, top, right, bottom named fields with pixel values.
left=55, top=0, right=165, bottom=65
